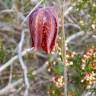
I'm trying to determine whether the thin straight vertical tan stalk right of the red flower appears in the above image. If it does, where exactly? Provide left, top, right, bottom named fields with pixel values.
left=61, top=0, right=68, bottom=96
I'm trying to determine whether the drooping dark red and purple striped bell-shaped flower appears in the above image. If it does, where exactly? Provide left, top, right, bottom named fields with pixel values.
left=29, top=7, right=58, bottom=53
